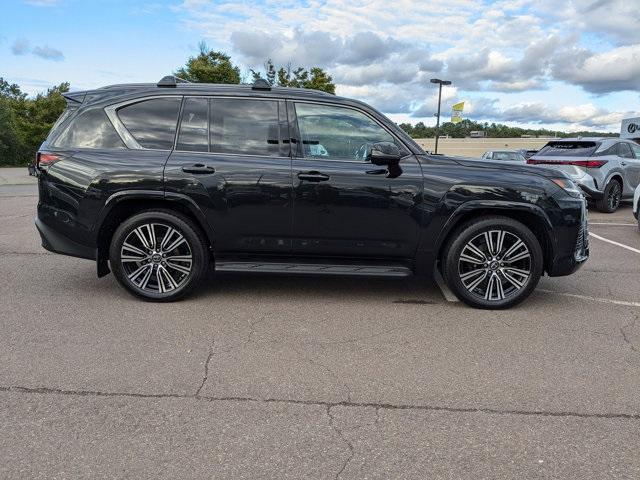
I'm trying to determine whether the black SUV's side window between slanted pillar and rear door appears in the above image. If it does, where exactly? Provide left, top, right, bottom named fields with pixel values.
left=118, top=97, right=181, bottom=150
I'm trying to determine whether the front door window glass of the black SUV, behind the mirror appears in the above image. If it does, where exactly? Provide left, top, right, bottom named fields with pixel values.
left=296, top=103, right=395, bottom=160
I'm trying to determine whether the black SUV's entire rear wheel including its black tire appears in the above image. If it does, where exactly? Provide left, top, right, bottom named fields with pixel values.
left=109, top=209, right=210, bottom=302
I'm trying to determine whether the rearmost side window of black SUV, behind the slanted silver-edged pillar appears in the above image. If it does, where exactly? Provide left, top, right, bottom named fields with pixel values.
left=53, top=108, right=125, bottom=148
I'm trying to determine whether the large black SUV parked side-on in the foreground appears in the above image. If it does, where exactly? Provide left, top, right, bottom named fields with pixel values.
left=34, top=76, right=588, bottom=308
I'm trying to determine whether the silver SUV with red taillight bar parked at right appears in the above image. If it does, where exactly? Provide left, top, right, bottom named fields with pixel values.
left=527, top=137, right=640, bottom=213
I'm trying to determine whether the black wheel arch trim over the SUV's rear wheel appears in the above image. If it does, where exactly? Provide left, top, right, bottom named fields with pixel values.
left=93, top=191, right=214, bottom=277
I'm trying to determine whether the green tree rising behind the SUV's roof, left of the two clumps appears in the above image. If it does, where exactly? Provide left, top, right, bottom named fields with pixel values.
left=174, top=42, right=240, bottom=83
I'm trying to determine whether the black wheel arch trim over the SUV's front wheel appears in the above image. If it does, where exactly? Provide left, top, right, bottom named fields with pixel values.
left=435, top=201, right=553, bottom=271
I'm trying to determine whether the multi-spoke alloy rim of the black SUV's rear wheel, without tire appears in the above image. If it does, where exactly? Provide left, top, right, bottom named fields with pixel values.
left=120, top=223, right=193, bottom=294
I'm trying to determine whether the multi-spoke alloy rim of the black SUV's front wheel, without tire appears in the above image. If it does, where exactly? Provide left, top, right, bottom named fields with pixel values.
left=458, top=230, right=532, bottom=301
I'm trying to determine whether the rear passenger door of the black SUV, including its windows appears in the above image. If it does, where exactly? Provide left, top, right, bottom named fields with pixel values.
left=165, top=96, right=292, bottom=253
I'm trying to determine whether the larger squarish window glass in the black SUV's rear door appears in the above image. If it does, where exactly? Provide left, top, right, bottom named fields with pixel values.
left=210, top=98, right=281, bottom=157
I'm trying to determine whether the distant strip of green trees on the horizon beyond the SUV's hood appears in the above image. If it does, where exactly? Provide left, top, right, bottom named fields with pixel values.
left=400, top=120, right=618, bottom=138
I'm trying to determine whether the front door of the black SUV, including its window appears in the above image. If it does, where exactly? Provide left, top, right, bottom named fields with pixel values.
left=288, top=102, right=423, bottom=258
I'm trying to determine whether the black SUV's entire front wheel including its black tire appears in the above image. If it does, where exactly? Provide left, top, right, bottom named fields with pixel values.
left=441, top=216, right=544, bottom=309
